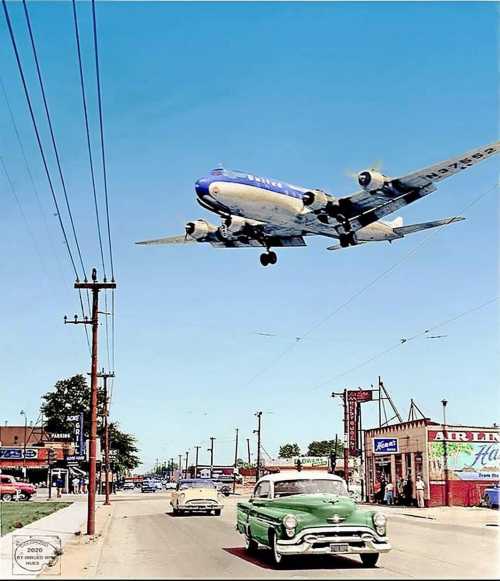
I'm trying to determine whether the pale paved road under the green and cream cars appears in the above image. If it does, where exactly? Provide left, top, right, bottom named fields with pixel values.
left=84, top=494, right=500, bottom=579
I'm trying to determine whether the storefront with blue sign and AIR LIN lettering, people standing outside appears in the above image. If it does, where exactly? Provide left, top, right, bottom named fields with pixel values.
left=365, top=419, right=500, bottom=506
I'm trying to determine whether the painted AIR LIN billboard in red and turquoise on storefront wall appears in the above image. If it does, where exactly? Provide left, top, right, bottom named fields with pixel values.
left=427, top=428, right=500, bottom=481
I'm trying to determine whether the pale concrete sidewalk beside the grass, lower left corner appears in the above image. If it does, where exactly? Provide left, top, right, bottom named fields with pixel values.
left=0, top=499, right=87, bottom=579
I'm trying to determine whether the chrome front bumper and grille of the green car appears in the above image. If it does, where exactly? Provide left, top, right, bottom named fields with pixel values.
left=277, top=527, right=392, bottom=555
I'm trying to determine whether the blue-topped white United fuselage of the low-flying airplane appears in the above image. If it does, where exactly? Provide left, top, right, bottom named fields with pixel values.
left=195, top=169, right=400, bottom=241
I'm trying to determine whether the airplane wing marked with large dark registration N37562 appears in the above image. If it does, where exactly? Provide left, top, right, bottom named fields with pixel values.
left=334, top=141, right=500, bottom=231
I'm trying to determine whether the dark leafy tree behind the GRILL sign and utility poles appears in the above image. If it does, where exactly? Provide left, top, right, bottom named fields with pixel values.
left=41, top=374, right=140, bottom=474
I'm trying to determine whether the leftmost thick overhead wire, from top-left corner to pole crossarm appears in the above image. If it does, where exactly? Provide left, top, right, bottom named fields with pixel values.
left=2, top=0, right=90, bottom=351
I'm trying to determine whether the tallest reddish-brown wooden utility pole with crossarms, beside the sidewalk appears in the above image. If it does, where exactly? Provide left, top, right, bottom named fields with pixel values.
left=64, top=268, right=116, bottom=536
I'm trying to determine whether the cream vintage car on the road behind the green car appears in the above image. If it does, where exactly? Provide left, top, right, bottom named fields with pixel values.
left=170, top=478, right=224, bottom=516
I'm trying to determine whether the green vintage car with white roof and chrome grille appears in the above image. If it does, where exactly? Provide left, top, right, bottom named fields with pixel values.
left=236, top=471, right=391, bottom=567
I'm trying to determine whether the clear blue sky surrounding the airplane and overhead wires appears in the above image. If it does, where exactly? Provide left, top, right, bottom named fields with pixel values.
left=0, top=2, right=498, bottom=465
